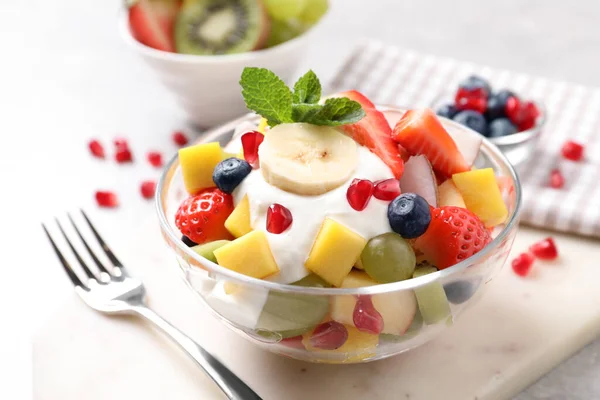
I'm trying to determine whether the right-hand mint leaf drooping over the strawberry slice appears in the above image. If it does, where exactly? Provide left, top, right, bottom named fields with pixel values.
left=292, top=97, right=365, bottom=126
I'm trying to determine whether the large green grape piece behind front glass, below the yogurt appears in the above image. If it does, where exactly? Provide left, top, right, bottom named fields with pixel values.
left=256, top=274, right=329, bottom=339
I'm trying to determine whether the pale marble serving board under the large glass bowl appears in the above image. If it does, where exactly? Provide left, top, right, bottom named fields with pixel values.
left=33, top=216, right=600, bottom=400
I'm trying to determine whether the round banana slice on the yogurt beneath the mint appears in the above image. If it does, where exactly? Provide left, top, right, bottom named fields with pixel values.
left=258, top=123, right=358, bottom=196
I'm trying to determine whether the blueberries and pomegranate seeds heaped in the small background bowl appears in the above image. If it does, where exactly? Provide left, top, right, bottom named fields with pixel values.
left=437, top=75, right=541, bottom=138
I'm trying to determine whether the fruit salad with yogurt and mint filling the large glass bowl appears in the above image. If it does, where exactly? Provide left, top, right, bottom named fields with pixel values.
left=175, top=68, right=508, bottom=362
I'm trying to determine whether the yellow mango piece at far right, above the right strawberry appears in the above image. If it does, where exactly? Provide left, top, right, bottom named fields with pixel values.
left=452, top=168, right=508, bottom=228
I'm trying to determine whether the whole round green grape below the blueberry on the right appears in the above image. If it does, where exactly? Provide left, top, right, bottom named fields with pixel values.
left=360, top=232, right=416, bottom=283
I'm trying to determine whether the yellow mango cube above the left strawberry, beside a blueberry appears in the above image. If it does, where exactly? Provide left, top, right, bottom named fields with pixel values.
left=179, top=142, right=223, bottom=194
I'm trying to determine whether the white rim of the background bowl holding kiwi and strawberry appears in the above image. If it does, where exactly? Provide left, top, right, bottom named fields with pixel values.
left=118, top=7, right=329, bottom=64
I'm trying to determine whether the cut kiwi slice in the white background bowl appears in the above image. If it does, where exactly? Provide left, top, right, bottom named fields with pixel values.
left=175, top=0, right=270, bottom=55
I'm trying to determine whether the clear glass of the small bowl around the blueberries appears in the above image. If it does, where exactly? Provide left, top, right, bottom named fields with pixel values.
left=431, top=94, right=546, bottom=167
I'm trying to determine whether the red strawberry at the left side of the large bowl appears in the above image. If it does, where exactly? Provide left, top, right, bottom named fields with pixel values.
left=175, top=187, right=233, bottom=244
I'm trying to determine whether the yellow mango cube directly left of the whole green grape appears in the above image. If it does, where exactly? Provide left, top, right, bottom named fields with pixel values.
left=304, top=218, right=367, bottom=287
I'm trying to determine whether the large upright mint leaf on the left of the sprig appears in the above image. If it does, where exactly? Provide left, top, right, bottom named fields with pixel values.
left=240, top=67, right=293, bottom=126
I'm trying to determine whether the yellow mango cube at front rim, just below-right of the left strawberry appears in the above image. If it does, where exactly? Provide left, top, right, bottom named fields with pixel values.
left=214, top=231, right=279, bottom=279
